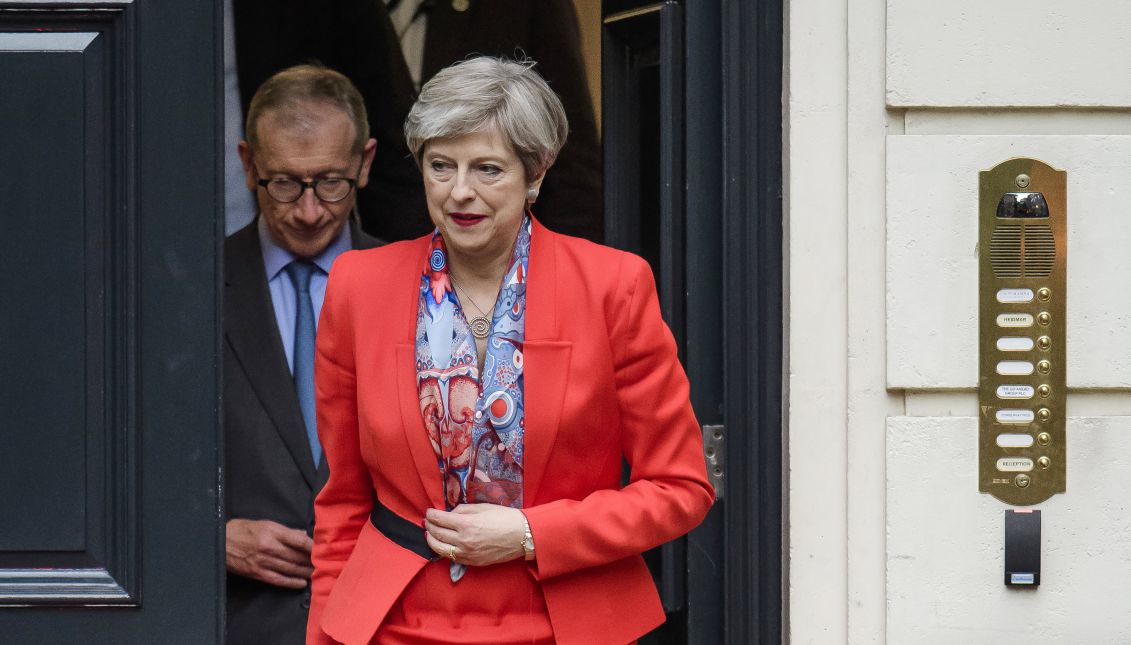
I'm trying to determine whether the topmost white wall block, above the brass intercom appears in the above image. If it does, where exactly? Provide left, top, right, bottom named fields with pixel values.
left=887, top=0, right=1131, bottom=108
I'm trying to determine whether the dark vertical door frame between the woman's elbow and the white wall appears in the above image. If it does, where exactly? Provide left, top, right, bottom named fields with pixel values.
left=685, top=0, right=786, bottom=645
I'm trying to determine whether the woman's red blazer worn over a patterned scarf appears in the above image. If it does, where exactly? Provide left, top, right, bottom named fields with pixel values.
left=308, top=218, right=714, bottom=644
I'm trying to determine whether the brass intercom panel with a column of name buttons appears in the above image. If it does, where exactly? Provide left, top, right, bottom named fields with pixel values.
left=978, top=158, right=1068, bottom=506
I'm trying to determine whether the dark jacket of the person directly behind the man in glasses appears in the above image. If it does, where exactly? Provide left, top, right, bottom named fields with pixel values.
left=232, top=0, right=429, bottom=240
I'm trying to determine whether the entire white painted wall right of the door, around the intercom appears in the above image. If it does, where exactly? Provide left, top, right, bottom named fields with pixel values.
left=785, top=0, right=1131, bottom=645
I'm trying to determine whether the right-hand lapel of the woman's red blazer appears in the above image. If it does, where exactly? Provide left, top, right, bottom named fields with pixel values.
left=523, top=222, right=571, bottom=504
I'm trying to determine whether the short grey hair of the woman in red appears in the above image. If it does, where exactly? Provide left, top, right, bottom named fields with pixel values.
left=405, top=57, right=569, bottom=180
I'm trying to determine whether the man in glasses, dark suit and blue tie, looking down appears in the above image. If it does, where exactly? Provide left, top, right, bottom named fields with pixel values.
left=224, top=66, right=379, bottom=645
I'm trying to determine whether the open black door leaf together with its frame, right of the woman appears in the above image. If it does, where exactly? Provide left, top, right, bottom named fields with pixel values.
left=602, top=0, right=783, bottom=644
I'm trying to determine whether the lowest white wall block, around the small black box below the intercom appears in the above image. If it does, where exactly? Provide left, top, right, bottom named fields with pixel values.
left=887, top=416, right=1131, bottom=645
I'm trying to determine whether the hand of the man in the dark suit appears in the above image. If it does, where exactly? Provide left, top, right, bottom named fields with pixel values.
left=224, top=519, right=314, bottom=590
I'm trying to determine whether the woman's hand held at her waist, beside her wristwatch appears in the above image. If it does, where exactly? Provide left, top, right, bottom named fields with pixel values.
left=424, top=504, right=525, bottom=567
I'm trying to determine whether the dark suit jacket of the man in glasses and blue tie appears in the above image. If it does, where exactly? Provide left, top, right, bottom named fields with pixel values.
left=224, top=222, right=380, bottom=645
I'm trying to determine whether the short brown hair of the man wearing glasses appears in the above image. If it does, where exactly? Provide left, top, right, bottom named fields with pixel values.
left=244, top=63, right=369, bottom=153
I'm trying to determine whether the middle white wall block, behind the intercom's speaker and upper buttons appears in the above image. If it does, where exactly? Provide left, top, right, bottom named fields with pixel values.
left=886, top=135, right=1131, bottom=389
